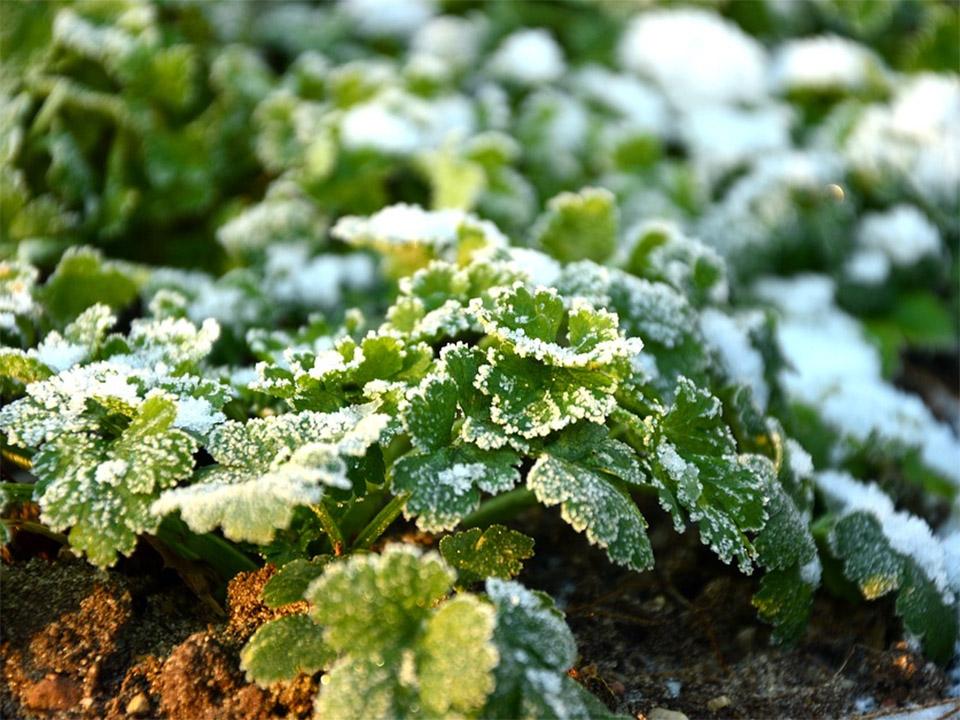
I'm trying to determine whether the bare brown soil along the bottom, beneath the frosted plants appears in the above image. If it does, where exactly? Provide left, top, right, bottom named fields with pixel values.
left=0, top=510, right=946, bottom=720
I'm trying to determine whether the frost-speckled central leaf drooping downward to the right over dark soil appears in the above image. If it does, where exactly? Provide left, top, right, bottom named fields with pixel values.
left=527, top=424, right=653, bottom=571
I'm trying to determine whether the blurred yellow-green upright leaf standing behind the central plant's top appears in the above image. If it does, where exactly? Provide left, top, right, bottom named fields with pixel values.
left=532, top=188, right=619, bottom=262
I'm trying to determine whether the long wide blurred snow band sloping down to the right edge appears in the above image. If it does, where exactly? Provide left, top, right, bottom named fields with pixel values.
left=754, top=275, right=960, bottom=485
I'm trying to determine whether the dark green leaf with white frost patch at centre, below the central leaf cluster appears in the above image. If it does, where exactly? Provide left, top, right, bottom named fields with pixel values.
left=390, top=445, right=520, bottom=532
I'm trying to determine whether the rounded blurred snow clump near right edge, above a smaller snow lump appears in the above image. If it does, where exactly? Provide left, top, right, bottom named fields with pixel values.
left=857, top=205, right=940, bottom=267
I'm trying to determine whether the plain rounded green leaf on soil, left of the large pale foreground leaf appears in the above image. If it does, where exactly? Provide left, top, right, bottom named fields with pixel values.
left=240, top=615, right=336, bottom=686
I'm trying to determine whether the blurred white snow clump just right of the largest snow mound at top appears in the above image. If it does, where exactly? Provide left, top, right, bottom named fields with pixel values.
left=770, top=35, right=880, bottom=92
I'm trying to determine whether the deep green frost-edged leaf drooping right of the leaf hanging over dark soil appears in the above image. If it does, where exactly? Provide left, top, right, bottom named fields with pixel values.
left=648, top=376, right=774, bottom=573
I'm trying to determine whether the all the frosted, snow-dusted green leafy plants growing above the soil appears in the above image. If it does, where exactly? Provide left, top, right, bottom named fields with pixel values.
left=0, top=0, right=960, bottom=718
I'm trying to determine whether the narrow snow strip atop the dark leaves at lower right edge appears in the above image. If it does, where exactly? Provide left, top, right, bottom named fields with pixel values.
left=816, top=470, right=953, bottom=602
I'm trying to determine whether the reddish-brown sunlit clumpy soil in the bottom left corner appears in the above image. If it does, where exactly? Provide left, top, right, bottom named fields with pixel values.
left=0, top=558, right=317, bottom=720
